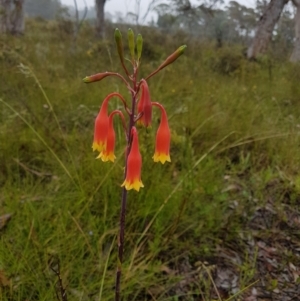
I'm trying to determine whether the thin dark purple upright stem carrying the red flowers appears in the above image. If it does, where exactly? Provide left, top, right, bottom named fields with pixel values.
left=115, top=70, right=137, bottom=301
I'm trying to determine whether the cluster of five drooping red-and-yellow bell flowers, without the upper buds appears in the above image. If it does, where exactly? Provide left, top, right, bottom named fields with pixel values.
left=92, top=83, right=171, bottom=191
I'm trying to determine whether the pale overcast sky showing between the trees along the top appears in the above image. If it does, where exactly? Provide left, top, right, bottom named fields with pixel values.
left=61, top=0, right=255, bottom=21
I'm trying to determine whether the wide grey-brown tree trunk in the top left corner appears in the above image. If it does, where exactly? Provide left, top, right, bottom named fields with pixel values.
left=0, top=0, right=25, bottom=34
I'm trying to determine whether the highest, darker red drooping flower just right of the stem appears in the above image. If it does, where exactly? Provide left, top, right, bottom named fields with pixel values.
left=138, top=79, right=152, bottom=127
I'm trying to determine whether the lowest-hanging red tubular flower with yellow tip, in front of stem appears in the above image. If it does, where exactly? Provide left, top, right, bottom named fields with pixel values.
left=122, top=127, right=144, bottom=191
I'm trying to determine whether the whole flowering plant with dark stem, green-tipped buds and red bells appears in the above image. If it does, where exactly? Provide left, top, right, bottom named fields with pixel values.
left=83, top=29, right=186, bottom=301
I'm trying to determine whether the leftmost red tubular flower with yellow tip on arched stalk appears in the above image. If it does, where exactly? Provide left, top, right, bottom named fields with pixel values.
left=92, top=92, right=126, bottom=152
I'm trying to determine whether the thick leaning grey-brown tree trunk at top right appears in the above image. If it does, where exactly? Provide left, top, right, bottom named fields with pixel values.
left=247, top=0, right=289, bottom=59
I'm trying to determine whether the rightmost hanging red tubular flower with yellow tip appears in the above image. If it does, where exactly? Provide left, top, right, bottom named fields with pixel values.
left=152, top=102, right=171, bottom=164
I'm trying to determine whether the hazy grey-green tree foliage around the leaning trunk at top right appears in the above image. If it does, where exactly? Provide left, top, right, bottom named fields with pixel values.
left=155, top=0, right=295, bottom=56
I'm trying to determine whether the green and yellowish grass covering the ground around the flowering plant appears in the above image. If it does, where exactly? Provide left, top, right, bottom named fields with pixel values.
left=0, top=21, right=300, bottom=301
